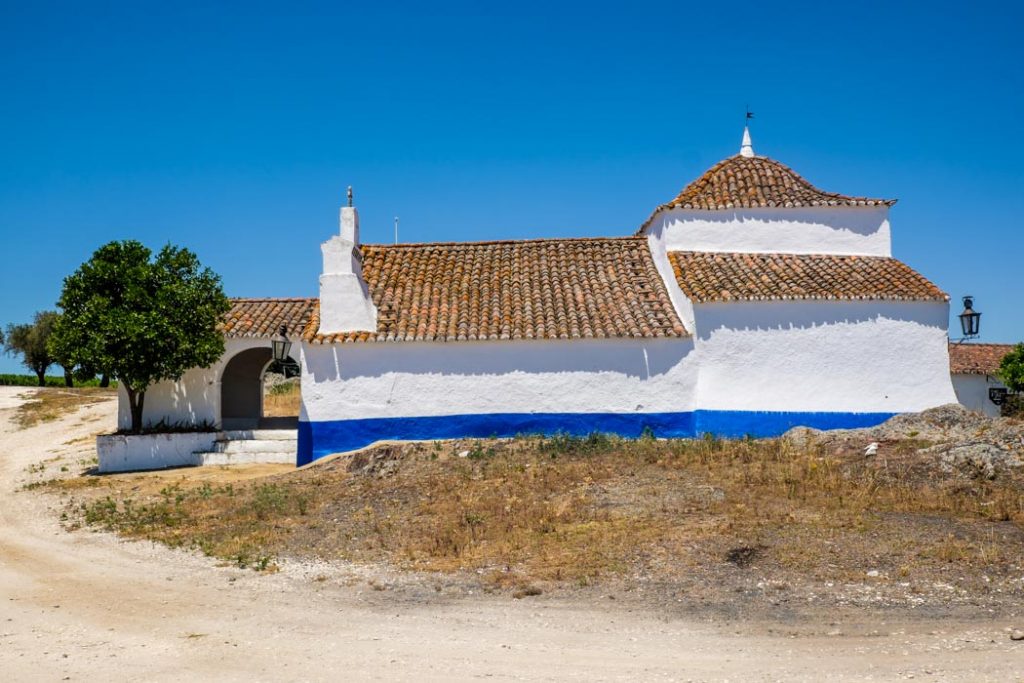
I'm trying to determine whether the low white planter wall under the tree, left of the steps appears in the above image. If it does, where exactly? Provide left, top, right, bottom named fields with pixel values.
left=96, top=432, right=217, bottom=473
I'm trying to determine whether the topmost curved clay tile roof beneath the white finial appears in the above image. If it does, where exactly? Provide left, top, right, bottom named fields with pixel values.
left=640, top=155, right=896, bottom=230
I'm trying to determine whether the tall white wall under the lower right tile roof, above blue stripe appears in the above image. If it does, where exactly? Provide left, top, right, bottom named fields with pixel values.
left=694, top=301, right=955, bottom=413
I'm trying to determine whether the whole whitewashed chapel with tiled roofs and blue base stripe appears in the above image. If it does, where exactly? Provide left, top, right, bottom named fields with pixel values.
left=123, top=131, right=974, bottom=464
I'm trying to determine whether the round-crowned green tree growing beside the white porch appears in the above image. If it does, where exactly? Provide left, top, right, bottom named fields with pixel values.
left=51, top=240, right=230, bottom=434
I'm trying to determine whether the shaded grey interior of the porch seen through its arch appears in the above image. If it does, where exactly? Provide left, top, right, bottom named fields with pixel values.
left=220, top=347, right=298, bottom=429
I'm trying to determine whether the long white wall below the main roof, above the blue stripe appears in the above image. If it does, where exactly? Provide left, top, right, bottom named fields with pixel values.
left=300, top=339, right=696, bottom=421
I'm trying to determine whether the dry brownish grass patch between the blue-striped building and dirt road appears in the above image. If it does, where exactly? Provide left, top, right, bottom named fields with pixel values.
left=56, top=436, right=1024, bottom=594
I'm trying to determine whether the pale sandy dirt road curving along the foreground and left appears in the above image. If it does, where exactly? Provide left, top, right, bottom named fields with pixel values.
left=0, top=387, right=1024, bottom=681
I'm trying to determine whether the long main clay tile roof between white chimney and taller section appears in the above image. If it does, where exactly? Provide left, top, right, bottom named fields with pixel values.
left=306, top=238, right=687, bottom=343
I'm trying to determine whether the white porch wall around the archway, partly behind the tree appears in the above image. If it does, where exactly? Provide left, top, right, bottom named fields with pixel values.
left=118, top=337, right=299, bottom=429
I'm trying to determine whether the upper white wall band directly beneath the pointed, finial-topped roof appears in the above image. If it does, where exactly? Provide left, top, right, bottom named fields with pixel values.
left=645, top=206, right=892, bottom=256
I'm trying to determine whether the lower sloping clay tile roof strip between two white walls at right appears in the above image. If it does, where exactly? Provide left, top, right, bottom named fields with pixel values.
left=669, top=252, right=949, bottom=303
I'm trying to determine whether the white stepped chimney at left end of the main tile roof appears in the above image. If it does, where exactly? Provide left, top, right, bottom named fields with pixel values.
left=319, top=187, right=377, bottom=334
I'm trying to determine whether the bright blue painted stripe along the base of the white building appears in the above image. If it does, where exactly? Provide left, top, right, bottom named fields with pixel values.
left=297, top=411, right=895, bottom=466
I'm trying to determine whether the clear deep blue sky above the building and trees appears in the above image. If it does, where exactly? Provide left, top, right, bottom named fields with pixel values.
left=0, top=0, right=1024, bottom=371
